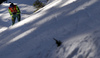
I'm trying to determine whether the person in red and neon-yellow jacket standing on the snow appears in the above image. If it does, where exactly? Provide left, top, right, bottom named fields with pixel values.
left=8, top=3, right=21, bottom=25
